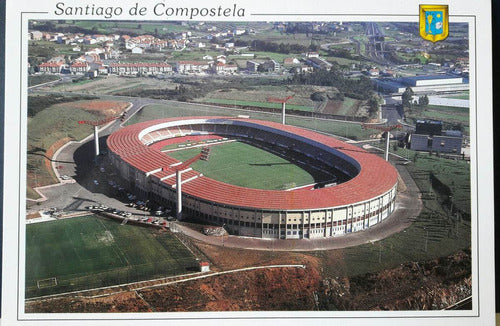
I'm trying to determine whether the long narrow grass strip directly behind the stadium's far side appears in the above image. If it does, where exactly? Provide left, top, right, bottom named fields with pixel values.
left=126, top=102, right=376, bottom=140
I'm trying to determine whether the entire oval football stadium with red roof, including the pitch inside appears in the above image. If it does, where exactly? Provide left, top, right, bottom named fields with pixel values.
left=107, top=116, right=398, bottom=239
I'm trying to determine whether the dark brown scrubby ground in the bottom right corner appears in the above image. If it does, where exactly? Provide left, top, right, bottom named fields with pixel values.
left=321, top=251, right=472, bottom=310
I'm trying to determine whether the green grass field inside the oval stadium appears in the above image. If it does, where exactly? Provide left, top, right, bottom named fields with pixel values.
left=168, top=142, right=315, bottom=190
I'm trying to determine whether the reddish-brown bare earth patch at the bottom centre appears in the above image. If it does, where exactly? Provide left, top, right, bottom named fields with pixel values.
left=141, top=268, right=320, bottom=311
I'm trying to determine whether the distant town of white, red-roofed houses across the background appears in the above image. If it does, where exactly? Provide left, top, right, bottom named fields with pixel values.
left=28, top=22, right=469, bottom=93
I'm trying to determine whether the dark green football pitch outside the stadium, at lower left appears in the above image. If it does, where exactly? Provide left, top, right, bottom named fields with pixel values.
left=25, top=216, right=197, bottom=298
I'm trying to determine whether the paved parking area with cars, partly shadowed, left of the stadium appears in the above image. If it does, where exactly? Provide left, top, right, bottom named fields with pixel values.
left=27, top=140, right=175, bottom=225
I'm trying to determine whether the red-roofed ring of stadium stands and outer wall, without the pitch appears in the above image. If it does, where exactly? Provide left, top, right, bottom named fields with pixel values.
left=107, top=117, right=398, bottom=239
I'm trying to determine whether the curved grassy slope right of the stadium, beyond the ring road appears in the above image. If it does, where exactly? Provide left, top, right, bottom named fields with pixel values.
left=314, top=153, right=472, bottom=277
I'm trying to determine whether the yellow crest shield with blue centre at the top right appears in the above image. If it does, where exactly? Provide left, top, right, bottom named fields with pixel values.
left=419, top=5, right=448, bottom=42
